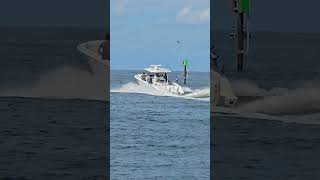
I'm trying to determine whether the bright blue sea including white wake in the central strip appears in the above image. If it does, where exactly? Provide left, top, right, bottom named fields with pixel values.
left=110, top=70, right=210, bottom=179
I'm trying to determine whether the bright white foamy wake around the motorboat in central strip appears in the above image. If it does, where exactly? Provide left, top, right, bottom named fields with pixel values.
left=111, top=82, right=210, bottom=101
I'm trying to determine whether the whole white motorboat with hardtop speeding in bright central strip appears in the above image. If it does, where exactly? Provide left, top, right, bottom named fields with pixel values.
left=134, top=65, right=185, bottom=95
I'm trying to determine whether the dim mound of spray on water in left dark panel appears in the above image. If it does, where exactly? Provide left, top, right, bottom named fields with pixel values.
left=0, top=67, right=108, bottom=101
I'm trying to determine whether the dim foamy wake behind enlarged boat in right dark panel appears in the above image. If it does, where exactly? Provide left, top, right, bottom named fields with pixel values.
left=213, top=81, right=320, bottom=124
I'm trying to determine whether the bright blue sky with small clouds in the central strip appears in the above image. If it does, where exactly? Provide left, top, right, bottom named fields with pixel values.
left=110, top=0, right=210, bottom=72
